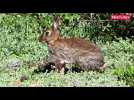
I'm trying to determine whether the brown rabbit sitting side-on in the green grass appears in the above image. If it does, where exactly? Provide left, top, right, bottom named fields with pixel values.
left=39, top=17, right=105, bottom=73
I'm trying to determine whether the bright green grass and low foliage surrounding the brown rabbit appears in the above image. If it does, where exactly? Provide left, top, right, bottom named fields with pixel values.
left=0, top=14, right=134, bottom=87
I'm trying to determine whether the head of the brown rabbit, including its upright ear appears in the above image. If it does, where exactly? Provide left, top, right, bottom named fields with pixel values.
left=39, top=16, right=60, bottom=44
